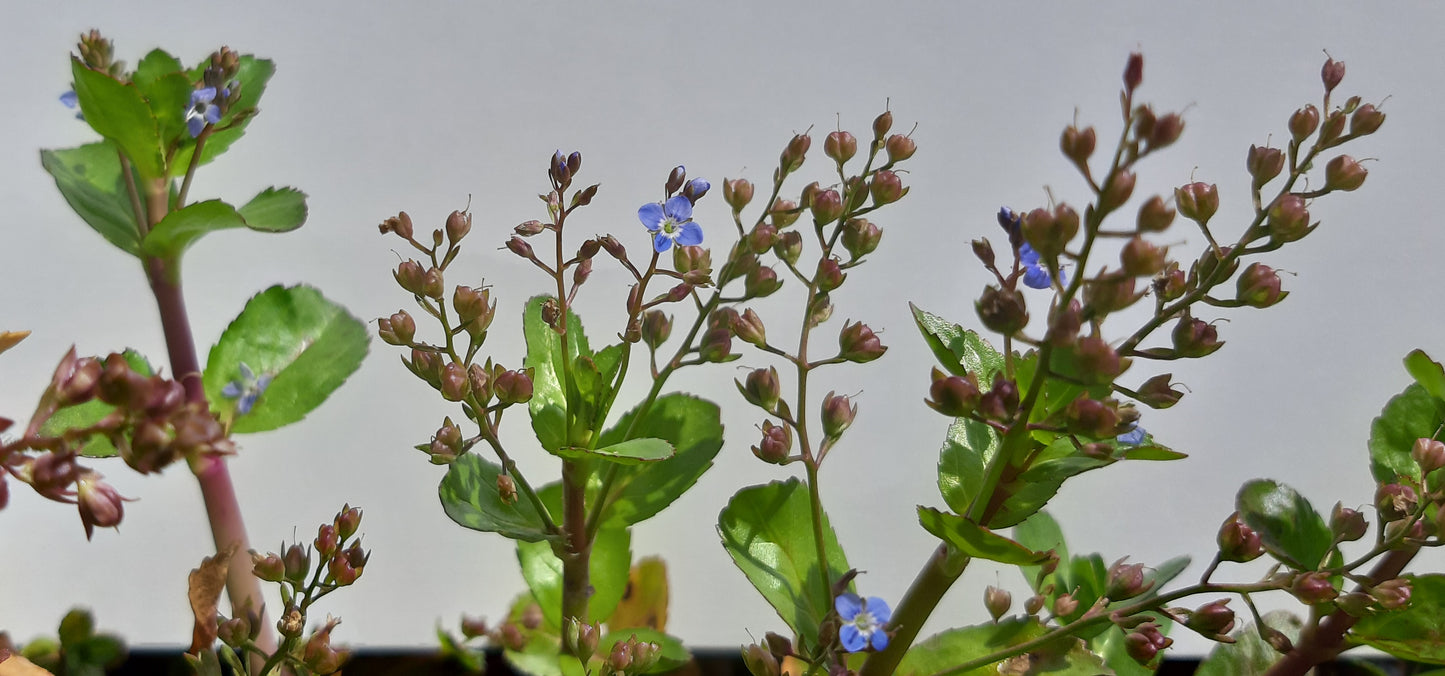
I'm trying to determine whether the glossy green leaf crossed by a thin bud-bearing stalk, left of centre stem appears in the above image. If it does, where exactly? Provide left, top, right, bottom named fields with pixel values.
left=438, top=454, right=549, bottom=542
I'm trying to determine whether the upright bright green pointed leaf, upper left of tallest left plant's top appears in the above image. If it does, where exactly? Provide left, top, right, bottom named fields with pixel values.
left=71, top=56, right=166, bottom=179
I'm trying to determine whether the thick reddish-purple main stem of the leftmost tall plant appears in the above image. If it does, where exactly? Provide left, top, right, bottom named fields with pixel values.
left=145, top=181, right=276, bottom=664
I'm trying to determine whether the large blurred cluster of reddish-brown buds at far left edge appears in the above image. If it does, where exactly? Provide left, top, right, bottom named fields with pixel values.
left=0, top=348, right=236, bottom=537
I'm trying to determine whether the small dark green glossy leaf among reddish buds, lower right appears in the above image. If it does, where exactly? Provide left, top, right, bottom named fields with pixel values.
left=1234, top=480, right=1334, bottom=571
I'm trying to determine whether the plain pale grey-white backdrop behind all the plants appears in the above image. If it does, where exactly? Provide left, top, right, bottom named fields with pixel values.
left=0, top=1, right=1445, bottom=661
